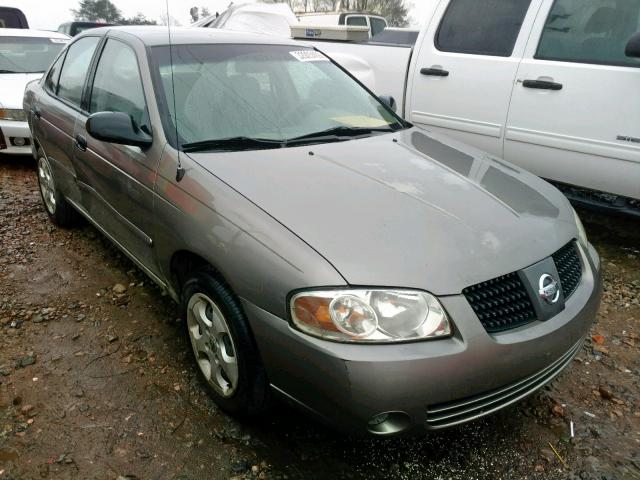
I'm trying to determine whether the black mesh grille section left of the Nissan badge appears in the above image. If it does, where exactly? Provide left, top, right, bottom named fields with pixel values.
left=462, top=272, right=536, bottom=332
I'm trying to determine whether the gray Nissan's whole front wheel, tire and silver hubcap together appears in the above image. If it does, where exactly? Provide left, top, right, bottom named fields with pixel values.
left=181, top=268, right=269, bottom=416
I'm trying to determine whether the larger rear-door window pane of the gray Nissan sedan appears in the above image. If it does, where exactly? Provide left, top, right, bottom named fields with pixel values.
left=58, top=37, right=100, bottom=106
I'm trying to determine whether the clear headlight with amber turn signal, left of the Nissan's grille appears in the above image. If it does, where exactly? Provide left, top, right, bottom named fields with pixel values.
left=290, top=289, right=451, bottom=343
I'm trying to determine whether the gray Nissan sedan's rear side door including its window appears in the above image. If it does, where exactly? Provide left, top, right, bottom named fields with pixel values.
left=31, top=37, right=100, bottom=203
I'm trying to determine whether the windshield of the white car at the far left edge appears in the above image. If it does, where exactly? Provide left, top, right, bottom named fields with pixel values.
left=0, top=37, right=67, bottom=73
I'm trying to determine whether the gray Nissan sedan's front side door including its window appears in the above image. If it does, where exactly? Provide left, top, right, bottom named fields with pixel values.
left=74, top=38, right=163, bottom=275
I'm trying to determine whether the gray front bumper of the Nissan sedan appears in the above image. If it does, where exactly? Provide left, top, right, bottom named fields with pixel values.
left=244, top=247, right=602, bottom=434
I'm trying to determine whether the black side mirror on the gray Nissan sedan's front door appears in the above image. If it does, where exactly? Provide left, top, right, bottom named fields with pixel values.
left=86, top=112, right=153, bottom=150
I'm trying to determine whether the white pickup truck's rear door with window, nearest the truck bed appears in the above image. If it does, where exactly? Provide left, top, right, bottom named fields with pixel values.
left=405, top=0, right=542, bottom=156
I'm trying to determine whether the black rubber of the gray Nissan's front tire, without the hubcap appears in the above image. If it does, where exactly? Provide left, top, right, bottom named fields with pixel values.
left=181, top=268, right=267, bottom=415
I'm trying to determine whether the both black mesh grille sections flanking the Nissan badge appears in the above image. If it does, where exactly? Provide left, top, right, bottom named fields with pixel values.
left=462, top=241, right=582, bottom=333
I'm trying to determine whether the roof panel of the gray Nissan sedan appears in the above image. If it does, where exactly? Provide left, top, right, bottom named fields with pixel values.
left=76, top=25, right=308, bottom=47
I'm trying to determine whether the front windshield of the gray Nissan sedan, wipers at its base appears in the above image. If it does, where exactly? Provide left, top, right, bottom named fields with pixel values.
left=153, top=44, right=404, bottom=149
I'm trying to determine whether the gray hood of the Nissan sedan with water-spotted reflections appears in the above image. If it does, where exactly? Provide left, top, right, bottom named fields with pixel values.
left=191, top=128, right=577, bottom=295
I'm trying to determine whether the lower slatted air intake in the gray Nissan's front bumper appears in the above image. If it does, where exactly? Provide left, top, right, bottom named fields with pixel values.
left=427, top=339, right=584, bottom=430
